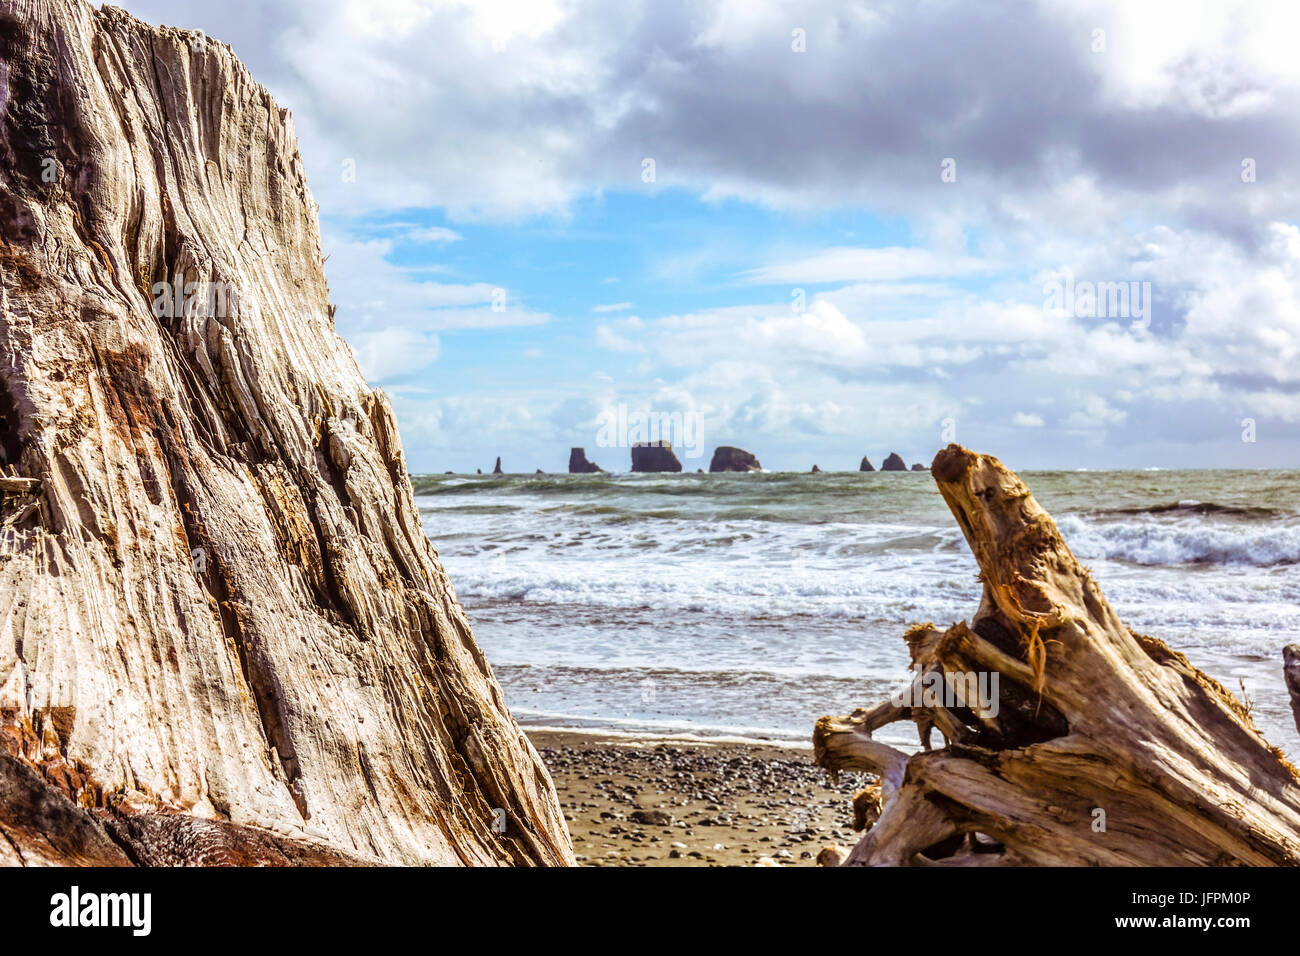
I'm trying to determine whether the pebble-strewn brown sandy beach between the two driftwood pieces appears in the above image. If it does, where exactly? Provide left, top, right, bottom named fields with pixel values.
left=529, top=731, right=866, bottom=866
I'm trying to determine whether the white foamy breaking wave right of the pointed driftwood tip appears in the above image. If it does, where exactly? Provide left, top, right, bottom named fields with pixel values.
left=1057, top=515, right=1300, bottom=567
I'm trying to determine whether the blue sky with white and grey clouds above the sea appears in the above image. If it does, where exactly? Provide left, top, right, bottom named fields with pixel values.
left=118, top=0, right=1300, bottom=472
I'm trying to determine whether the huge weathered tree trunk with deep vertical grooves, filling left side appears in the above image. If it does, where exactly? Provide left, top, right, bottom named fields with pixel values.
left=0, top=0, right=573, bottom=865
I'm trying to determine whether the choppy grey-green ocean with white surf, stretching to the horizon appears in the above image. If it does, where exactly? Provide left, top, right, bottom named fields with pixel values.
left=412, top=471, right=1300, bottom=757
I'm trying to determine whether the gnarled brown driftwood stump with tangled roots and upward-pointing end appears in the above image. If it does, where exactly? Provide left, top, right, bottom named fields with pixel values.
left=814, top=445, right=1300, bottom=866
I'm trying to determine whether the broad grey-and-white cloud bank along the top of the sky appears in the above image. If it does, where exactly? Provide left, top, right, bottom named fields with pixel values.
left=119, top=0, right=1300, bottom=230
